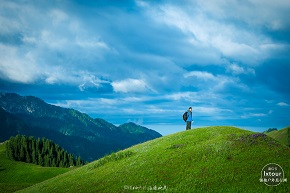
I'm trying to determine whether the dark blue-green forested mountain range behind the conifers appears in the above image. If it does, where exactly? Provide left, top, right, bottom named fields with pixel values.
left=0, top=92, right=162, bottom=161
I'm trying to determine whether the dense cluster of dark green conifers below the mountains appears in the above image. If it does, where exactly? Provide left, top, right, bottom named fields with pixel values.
left=6, top=135, right=84, bottom=167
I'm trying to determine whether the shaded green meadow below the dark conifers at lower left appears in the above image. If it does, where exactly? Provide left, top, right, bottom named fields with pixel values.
left=0, top=143, right=69, bottom=193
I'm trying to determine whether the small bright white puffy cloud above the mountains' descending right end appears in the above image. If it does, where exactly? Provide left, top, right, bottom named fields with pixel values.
left=112, top=78, right=150, bottom=93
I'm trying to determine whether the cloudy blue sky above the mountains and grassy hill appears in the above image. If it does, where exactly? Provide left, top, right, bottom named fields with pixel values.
left=0, top=0, right=290, bottom=133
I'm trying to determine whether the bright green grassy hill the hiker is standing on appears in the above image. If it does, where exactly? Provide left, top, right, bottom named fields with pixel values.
left=21, top=127, right=290, bottom=193
